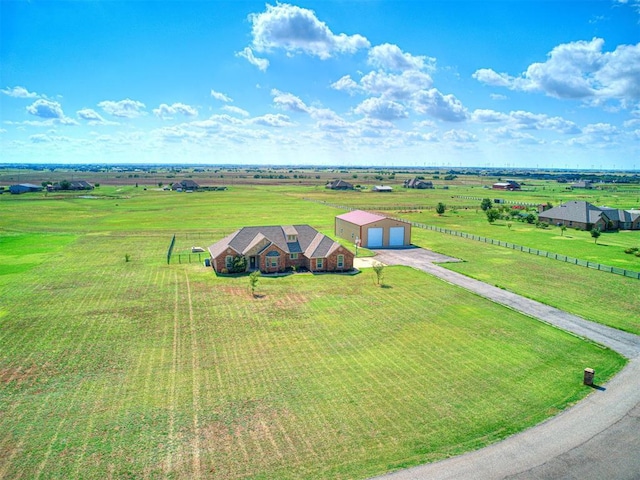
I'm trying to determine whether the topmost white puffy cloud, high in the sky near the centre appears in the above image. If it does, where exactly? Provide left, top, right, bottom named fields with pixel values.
left=245, top=3, right=370, bottom=59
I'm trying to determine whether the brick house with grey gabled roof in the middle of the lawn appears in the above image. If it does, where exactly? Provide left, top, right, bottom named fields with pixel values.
left=209, top=225, right=353, bottom=273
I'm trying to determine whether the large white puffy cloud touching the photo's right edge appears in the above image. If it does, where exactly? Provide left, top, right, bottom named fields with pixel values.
left=473, top=38, right=640, bottom=108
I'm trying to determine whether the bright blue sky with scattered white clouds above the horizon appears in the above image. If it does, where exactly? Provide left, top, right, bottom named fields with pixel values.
left=0, top=0, right=640, bottom=169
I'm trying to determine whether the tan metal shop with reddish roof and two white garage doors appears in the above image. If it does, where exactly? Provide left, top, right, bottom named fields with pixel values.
left=335, top=210, right=411, bottom=248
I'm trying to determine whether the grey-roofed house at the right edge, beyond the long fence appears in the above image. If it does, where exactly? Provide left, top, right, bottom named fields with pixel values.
left=538, top=200, right=640, bottom=231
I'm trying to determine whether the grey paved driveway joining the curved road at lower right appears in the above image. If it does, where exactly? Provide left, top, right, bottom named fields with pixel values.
left=376, top=248, right=640, bottom=480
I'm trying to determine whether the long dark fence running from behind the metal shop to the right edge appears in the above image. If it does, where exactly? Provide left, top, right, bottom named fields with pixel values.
left=306, top=202, right=640, bottom=280
